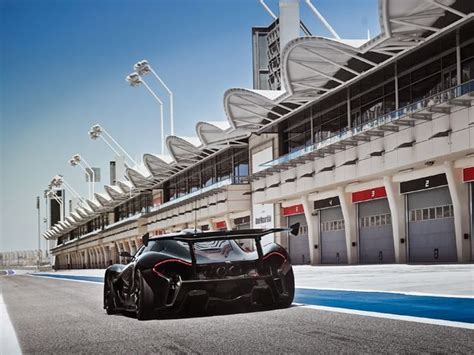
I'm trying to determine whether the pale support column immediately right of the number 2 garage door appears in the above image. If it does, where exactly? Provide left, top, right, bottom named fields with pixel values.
left=444, top=161, right=470, bottom=262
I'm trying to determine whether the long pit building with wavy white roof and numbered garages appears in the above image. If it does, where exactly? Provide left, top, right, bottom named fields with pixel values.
left=44, top=0, right=474, bottom=268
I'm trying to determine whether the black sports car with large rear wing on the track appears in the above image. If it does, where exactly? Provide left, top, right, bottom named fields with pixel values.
left=104, top=227, right=299, bottom=320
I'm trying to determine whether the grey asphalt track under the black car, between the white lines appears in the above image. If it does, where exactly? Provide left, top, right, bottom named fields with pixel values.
left=0, top=275, right=474, bottom=354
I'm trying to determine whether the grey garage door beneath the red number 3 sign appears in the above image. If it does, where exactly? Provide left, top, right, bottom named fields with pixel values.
left=357, top=198, right=395, bottom=263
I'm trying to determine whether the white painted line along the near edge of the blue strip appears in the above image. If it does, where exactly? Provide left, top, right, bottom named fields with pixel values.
left=293, top=303, right=474, bottom=329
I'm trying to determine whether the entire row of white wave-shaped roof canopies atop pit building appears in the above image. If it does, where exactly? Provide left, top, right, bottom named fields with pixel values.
left=50, top=0, right=472, bottom=241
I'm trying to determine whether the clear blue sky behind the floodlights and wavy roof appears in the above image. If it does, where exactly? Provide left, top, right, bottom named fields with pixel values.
left=0, top=0, right=379, bottom=251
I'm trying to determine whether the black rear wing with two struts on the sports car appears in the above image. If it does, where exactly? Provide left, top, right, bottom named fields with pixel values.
left=142, top=223, right=300, bottom=268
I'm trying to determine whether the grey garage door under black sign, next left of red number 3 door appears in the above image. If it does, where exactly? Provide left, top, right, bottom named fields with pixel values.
left=319, top=206, right=347, bottom=264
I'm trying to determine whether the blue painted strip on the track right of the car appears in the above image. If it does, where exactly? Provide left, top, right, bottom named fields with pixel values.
left=295, top=288, right=474, bottom=323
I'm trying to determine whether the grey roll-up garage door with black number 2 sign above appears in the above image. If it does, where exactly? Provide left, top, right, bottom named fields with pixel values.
left=400, top=174, right=457, bottom=262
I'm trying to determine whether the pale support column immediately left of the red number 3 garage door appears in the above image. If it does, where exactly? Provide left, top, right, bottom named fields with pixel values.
left=337, top=187, right=358, bottom=264
